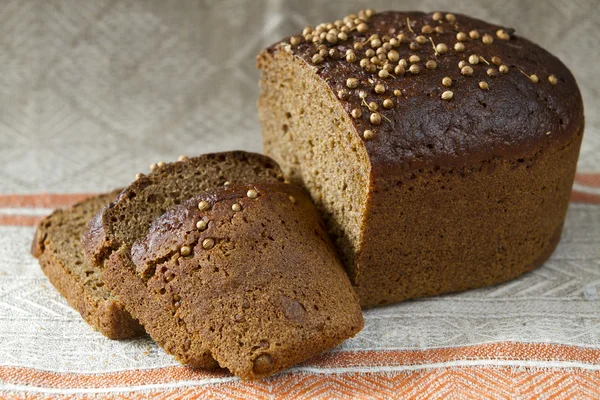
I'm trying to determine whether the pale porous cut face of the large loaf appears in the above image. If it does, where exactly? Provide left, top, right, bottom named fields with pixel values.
left=259, top=52, right=371, bottom=280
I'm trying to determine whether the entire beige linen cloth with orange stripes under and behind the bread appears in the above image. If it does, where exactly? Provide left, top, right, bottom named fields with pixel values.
left=0, top=0, right=600, bottom=399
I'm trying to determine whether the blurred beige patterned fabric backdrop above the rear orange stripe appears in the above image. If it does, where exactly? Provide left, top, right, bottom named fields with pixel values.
left=0, top=0, right=600, bottom=193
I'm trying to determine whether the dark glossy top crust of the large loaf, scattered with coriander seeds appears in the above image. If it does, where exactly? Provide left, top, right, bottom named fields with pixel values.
left=269, top=11, right=584, bottom=168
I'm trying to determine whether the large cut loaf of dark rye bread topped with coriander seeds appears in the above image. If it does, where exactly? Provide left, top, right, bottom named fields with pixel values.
left=258, top=10, right=584, bottom=306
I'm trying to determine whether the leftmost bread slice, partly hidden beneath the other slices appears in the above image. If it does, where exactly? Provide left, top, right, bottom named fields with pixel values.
left=31, top=191, right=145, bottom=339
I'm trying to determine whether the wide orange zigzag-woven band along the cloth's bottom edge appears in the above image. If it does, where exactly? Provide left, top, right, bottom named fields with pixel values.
left=0, top=367, right=600, bottom=400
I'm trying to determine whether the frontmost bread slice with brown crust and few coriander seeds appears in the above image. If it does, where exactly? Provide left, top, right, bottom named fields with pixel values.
left=105, top=182, right=363, bottom=379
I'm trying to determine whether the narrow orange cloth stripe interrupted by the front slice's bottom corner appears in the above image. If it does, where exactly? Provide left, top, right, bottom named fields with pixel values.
left=0, top=342, right=600, bottom=389
